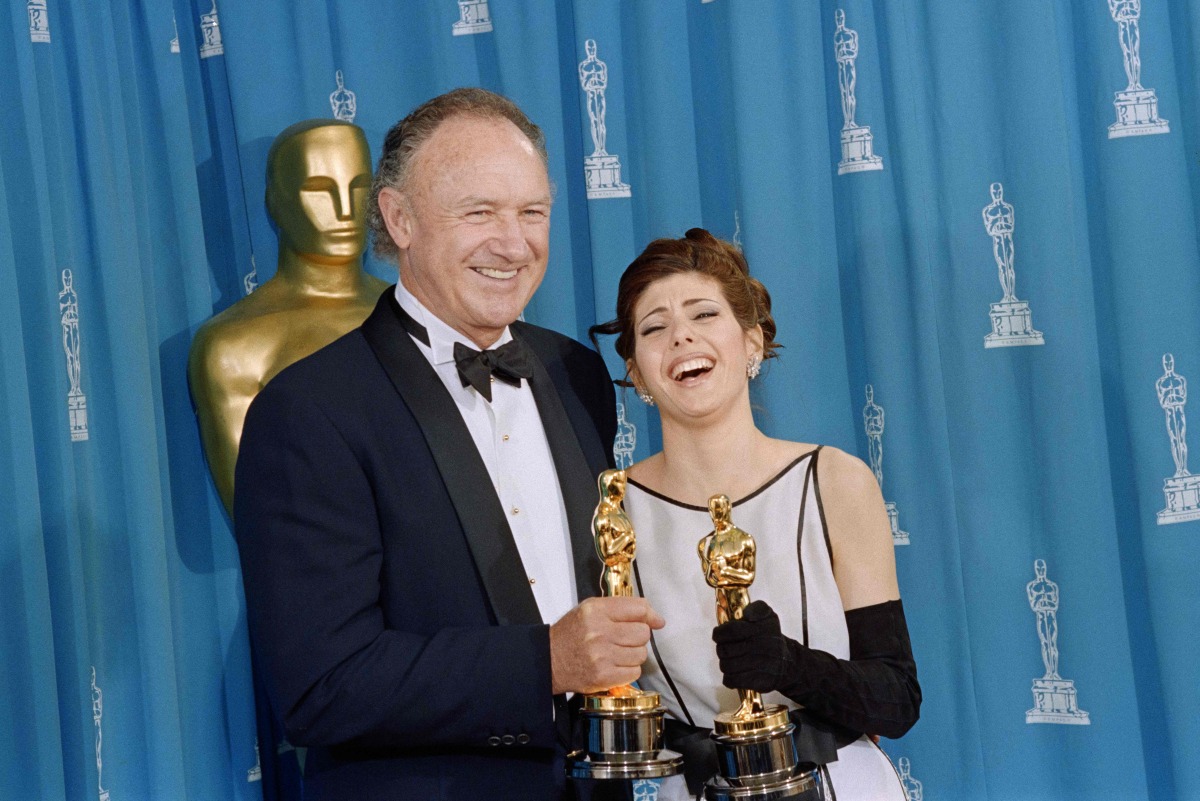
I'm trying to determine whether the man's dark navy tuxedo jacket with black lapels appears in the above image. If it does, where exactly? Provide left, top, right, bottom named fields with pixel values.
left=234, top=290, right=617, bottom=800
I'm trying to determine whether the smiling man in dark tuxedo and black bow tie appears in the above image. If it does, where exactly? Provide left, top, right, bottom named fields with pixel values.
left=235, top=89, right=662, bottom=800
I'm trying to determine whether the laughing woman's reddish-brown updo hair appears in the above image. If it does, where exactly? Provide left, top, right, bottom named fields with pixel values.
left=588, top=228, right=781, bottom=366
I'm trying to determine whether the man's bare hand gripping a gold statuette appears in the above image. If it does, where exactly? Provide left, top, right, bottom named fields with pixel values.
left=550, top=598, right=666, bottom=695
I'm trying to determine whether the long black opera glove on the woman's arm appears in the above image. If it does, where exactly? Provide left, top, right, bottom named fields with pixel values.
left=713, top=601, right=920, bottom=737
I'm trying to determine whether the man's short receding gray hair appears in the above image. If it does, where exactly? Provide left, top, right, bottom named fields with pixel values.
left=367, top=86, right=550, bottom=260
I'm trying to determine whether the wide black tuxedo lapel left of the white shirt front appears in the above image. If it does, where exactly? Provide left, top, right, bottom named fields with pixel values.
left=362, top=290, right=548, bottom=625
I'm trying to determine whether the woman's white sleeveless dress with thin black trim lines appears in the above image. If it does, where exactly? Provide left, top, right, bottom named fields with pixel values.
left=625, top=448, right=906, bottom=801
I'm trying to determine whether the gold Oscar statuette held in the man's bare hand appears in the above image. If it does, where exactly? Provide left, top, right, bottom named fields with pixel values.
left=566, top=470, right=683, bottom=779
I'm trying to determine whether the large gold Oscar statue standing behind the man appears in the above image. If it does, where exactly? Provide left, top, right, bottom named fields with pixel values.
left=187, top=120, right=386, bottom=514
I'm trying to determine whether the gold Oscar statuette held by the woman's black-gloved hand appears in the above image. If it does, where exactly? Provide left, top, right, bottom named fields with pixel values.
left=697, top=495, right=818, bottom=801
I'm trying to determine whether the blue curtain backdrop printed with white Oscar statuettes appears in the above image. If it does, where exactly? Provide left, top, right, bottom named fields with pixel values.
left=0, top=0, right=1200, bottom=801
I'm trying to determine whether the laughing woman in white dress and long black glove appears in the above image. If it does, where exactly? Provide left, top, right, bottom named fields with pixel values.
left=594, top=228, right=920, bottom=801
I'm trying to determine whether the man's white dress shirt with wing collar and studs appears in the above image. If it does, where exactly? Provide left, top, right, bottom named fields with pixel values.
left=396, top=282, right=578, bottom=624
